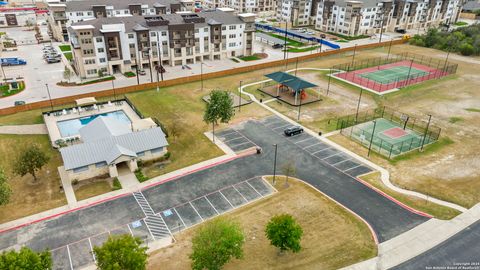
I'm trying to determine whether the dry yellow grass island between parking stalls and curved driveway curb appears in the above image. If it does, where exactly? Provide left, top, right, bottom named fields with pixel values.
left=148, top=178, right=377, bottom=269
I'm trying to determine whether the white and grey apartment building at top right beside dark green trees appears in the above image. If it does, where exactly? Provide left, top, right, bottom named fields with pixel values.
left=315, top=0, right=462, bottom=36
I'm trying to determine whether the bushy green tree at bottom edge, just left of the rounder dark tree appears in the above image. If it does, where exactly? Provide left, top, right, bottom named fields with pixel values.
left=190, top=218, right=245, bottom=270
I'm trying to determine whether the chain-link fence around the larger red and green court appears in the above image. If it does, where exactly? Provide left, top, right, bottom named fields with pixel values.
left=330, top=52, right=458, bottom=92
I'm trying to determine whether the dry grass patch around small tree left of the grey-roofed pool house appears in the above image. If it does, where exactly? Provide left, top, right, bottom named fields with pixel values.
left=0, top=135, right=66, bottom=223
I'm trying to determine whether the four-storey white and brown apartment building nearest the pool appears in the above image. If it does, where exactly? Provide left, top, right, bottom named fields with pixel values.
left=68, top=10, right=256, bottom=78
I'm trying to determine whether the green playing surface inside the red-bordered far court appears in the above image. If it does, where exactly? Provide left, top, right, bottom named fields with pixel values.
left=358, top=66, right=430, bottom=84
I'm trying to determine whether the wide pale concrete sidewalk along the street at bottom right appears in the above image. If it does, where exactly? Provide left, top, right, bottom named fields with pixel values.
left=342, top=203, right=480, bottom=270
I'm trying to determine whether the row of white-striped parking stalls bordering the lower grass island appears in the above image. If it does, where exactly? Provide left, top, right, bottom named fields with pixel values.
left=47, top=177, right=275, bottom=269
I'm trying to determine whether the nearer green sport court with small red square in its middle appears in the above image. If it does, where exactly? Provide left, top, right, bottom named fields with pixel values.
left=350, top=118, right=436, bottom=158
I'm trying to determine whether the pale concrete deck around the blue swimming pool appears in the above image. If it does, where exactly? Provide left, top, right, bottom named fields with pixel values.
left=43, top=101, right=141, bottom=147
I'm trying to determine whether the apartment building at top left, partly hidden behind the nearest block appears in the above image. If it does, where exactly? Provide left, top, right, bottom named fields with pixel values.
left=48, top=0, right=194, bottom=41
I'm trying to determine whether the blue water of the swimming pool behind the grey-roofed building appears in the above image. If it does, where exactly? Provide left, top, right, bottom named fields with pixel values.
left=57, top=111, right=131, bottom=137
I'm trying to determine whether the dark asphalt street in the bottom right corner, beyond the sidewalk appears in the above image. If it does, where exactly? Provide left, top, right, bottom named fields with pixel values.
left=393, top=221, right=480, bottom=270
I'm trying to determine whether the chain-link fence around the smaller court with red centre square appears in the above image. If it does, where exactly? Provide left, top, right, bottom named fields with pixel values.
left=337, top=107, right=441, bottom=158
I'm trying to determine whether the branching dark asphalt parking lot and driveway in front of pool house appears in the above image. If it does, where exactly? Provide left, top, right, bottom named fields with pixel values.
left=0, top=117, right=427, bottom=269
